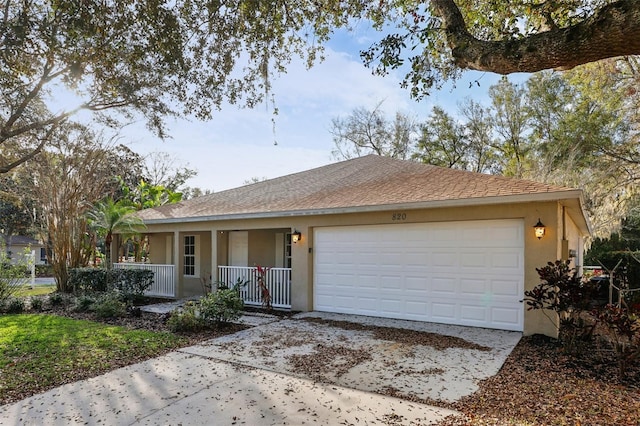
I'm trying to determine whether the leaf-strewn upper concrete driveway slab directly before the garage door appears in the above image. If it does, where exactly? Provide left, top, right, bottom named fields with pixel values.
left=181, top=312, right=521, bottom=402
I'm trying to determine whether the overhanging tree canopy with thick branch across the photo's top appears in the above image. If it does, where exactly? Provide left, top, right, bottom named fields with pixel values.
left=0, top=0, right=640, bottom=172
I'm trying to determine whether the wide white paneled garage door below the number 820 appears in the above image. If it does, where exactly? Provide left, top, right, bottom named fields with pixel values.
left=313, top=220, right=524, bottom=331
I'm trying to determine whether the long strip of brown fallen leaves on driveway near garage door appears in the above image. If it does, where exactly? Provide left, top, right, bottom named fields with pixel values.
left=298, top=317, right=491, bottom=352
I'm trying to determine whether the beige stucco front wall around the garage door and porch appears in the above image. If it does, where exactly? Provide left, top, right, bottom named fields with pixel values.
left=139, top=201, right=582, bottom=335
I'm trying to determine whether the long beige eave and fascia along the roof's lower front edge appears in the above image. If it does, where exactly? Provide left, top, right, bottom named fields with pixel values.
left=136, top=189, right=590, bottom=226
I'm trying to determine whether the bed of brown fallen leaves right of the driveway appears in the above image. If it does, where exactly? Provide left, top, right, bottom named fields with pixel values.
left=438, top=336, right=640, bottom=426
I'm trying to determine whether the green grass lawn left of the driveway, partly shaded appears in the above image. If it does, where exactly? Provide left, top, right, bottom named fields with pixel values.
left=0, top=314, right=185, bottom=405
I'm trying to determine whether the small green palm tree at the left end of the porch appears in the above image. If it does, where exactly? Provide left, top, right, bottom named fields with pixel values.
left=87, top=197, right=144, bottom=269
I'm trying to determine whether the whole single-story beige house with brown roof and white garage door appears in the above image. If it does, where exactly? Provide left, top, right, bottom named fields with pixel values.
left=119, top=155, right=590, bottom=335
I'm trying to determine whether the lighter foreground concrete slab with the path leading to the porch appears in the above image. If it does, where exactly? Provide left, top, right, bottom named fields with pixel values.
left=0, top=316, right=459, bottom=426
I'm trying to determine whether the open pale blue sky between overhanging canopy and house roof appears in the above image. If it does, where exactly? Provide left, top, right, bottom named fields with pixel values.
left=65, top=28, right=524, bottom=191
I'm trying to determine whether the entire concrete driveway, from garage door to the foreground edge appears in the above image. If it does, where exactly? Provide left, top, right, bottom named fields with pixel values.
left=0, top=313, right=520, bottom=425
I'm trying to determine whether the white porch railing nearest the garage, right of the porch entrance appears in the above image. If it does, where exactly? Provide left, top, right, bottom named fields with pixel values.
left=218, top=266, right=291, bottom=308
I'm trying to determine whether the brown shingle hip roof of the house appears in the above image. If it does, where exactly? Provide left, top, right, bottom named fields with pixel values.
left=139, top=155, right=571, bottom=222
